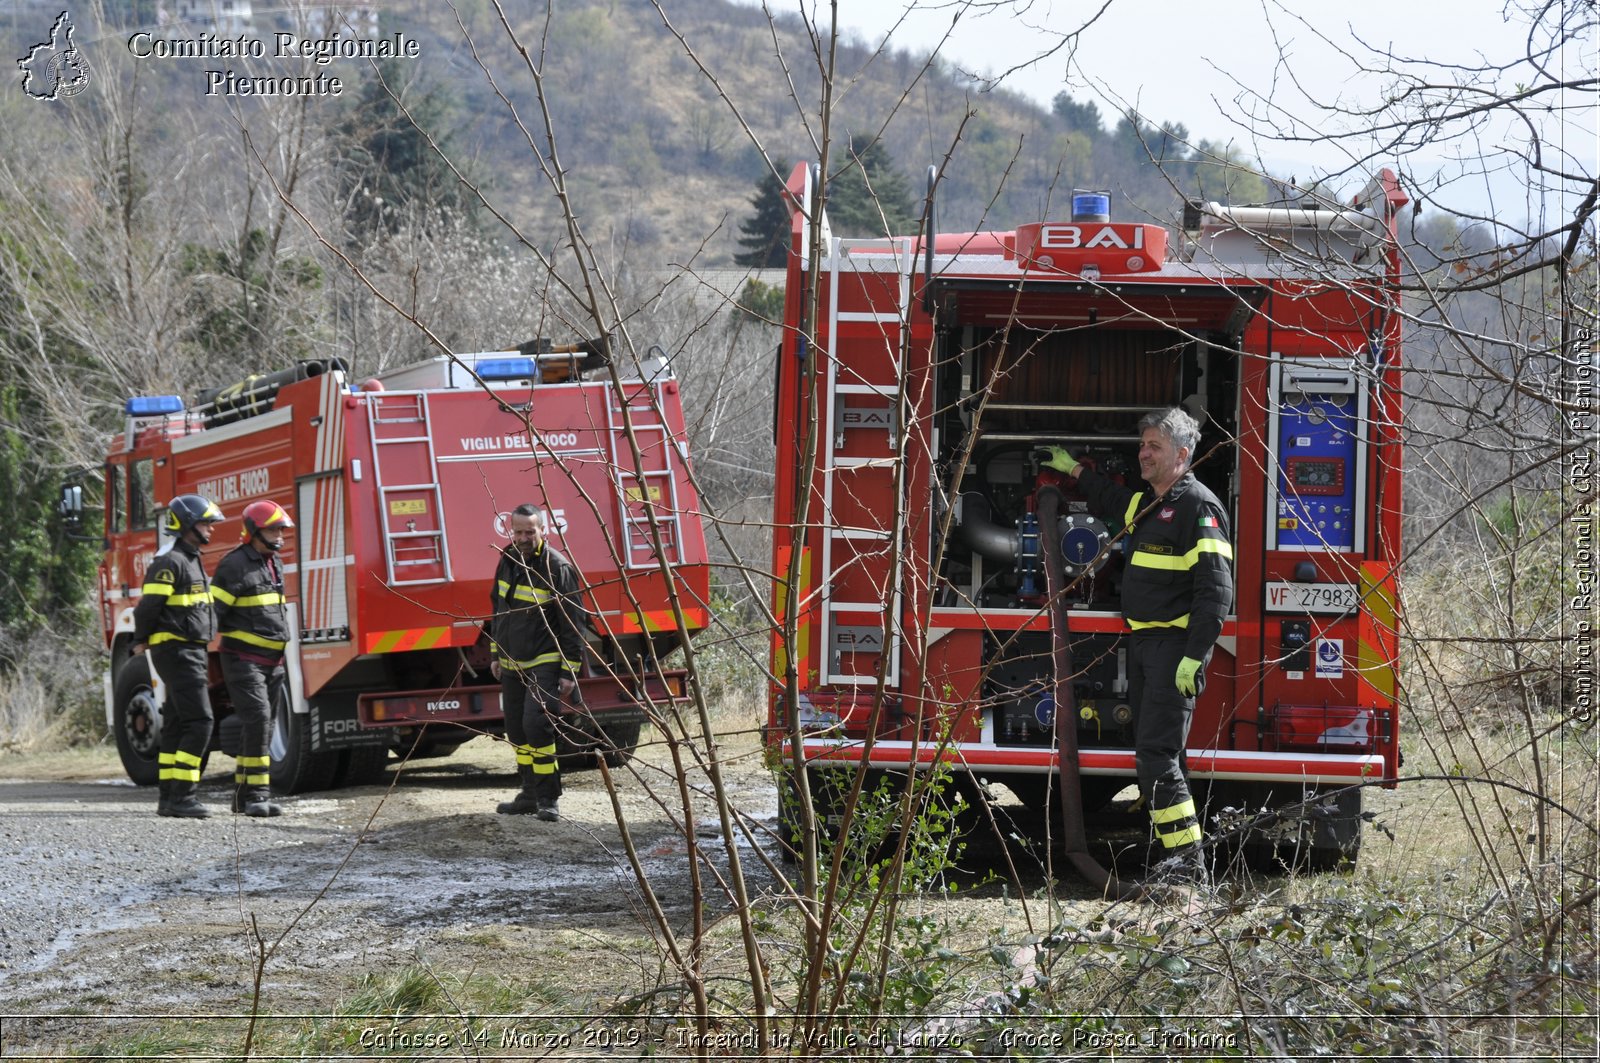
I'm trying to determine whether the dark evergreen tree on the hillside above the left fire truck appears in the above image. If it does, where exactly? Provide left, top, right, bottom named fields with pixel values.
left=336, top=59, right=472, bottom=235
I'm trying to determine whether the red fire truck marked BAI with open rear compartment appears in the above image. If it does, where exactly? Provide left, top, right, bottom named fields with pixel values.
left=768, top=165, right=1406, bottom=866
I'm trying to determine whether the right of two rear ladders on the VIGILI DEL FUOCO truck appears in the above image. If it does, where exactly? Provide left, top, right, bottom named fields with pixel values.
left=605, top=381, right=683, bottom=568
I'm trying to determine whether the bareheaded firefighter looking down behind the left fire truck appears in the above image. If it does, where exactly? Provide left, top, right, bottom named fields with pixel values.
left=490, top=504, right=584, bottom=823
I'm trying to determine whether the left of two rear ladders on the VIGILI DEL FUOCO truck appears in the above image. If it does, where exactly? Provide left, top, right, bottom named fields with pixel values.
left=366, top=391, right=451, bottom=588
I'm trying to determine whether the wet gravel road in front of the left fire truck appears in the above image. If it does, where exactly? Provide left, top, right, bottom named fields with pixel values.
left=0, top=740, right=778, bottom=1024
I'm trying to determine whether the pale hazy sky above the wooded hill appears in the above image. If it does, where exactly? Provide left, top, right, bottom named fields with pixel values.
left=738, top=0, right=1597, bottom=214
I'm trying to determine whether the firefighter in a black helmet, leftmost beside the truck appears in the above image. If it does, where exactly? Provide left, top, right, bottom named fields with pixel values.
left=133, top=495, right=222, bottom=820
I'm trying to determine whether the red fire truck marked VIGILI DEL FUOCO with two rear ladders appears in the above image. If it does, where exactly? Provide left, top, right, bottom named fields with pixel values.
left=67, top=341, right=709, bottom=792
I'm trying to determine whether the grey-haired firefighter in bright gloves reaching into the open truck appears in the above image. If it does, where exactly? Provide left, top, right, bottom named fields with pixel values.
left=1045, top=407, right=1234, bottom=882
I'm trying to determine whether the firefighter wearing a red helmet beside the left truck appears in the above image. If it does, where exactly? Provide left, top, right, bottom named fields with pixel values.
left=211, top=501, right=294, bottom=816
